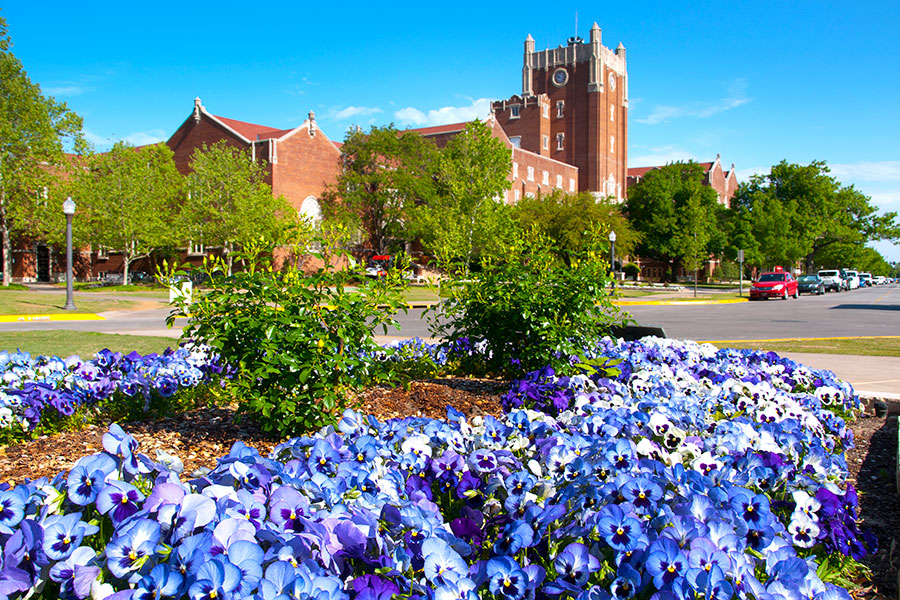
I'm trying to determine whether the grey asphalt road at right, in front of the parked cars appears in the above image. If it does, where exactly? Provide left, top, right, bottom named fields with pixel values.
left=626, top=285, right=900, bottom=340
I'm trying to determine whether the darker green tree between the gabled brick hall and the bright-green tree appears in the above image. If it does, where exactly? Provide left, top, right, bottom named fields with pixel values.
left=322, top=125, right=438, bottom=254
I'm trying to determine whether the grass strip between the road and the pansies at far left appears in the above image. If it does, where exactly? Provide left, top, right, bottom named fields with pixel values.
left=0, top=329, right=178, bottom=359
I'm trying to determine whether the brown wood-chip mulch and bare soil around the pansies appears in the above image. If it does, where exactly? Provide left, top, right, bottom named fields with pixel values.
left=0, top=378, right=900, bottom=600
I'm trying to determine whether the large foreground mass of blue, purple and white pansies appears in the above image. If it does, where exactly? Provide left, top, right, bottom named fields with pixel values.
left=0, top=340, right=871, bottom=600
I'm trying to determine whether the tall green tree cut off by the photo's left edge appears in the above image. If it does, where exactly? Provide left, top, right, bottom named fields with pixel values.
left=0, top=17, right=85, bottom=286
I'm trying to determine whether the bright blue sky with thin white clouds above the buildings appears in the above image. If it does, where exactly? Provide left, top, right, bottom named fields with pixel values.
left=0, top=0, right=900, bottom=260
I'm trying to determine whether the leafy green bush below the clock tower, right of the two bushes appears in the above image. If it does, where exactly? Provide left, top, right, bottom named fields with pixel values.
left=429, top=229, right=625, bottom=375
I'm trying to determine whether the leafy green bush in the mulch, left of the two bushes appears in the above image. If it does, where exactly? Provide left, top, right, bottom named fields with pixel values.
left=163, top=241, right=406, bottom=436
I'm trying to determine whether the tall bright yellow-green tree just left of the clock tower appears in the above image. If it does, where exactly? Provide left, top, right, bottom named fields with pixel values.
left=416, top=121, right=515, bottom=272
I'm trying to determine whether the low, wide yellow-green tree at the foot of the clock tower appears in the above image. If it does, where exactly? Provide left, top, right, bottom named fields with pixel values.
left=513, top=189, right=638, bottom=265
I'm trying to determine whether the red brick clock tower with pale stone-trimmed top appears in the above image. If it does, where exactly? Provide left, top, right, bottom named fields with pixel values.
left=491, top=23, right=628, bottom=200
